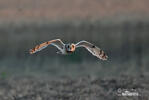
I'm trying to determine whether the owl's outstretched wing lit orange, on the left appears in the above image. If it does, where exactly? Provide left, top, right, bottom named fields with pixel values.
left=30, top=39, right=64, bottom=54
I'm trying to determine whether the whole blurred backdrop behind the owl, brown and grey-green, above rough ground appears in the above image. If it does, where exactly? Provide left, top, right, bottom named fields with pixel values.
left=0, top=0, right=149, bottom=78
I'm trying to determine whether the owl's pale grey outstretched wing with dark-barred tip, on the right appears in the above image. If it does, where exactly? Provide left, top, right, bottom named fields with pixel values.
left=76, top=41, right=108, bottom=60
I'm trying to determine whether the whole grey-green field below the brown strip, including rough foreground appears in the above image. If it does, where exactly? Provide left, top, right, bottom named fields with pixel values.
left=0, top=21, right=149, bottom=100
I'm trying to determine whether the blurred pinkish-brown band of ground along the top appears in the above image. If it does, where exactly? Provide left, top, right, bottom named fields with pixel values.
left=0, top=0, right=149, bottom=20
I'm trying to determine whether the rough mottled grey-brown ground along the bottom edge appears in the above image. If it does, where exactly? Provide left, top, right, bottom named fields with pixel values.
left=0, top=75, right=149, bottom=100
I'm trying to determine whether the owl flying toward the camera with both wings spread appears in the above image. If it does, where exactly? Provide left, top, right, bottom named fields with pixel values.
left=30, top=39, right=108, bottom=60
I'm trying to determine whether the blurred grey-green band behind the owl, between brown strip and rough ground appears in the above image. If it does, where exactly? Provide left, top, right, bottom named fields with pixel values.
left=0, top=20, right=149, bottom=76
